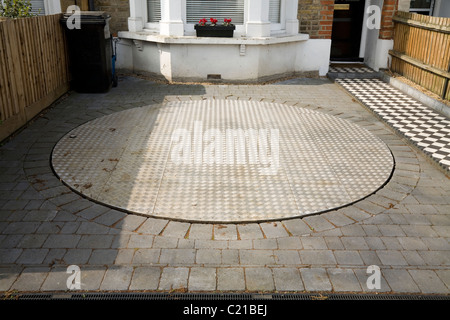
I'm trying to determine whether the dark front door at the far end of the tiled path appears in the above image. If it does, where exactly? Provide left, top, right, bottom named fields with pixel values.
left=331, top=0, right=365, bottom=61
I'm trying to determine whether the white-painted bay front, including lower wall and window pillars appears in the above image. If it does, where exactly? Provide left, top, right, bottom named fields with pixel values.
left=116, top=0, right=331, bottom=81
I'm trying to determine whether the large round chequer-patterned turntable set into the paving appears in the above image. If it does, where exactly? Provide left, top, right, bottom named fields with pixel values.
left=52, top=100, right=394, bottom=222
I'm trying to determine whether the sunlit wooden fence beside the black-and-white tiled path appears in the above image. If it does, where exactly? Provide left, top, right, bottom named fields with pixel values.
left=389, top=12, right=450, bottom=100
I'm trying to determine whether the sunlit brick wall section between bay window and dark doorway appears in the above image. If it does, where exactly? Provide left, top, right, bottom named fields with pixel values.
left=298, top=0, right=334, bottom=39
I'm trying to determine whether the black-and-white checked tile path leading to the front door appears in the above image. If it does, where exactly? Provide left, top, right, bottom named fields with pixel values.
left=336, top=78, right=450, bottom=171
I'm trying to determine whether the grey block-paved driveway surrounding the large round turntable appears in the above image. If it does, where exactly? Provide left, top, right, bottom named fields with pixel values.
left=0, top=77, right=450, bottom=294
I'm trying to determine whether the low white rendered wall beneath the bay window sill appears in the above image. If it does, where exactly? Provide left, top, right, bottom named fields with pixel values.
left=116, top=34, right=331, bottom=82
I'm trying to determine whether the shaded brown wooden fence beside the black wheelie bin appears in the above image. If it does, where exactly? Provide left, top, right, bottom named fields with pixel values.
left=0, top=14, right=69, bottom=141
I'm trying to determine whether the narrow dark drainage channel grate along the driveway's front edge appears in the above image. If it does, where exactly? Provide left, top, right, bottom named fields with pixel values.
left=0, top=292, right=450, bottom=301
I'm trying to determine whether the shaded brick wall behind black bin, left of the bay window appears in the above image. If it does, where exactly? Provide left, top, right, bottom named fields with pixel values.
left=61, top=0, right=130, bottom=34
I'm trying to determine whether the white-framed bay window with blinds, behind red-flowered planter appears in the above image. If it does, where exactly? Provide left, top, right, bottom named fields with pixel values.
left=132, top=0, right=298, bottom=37
